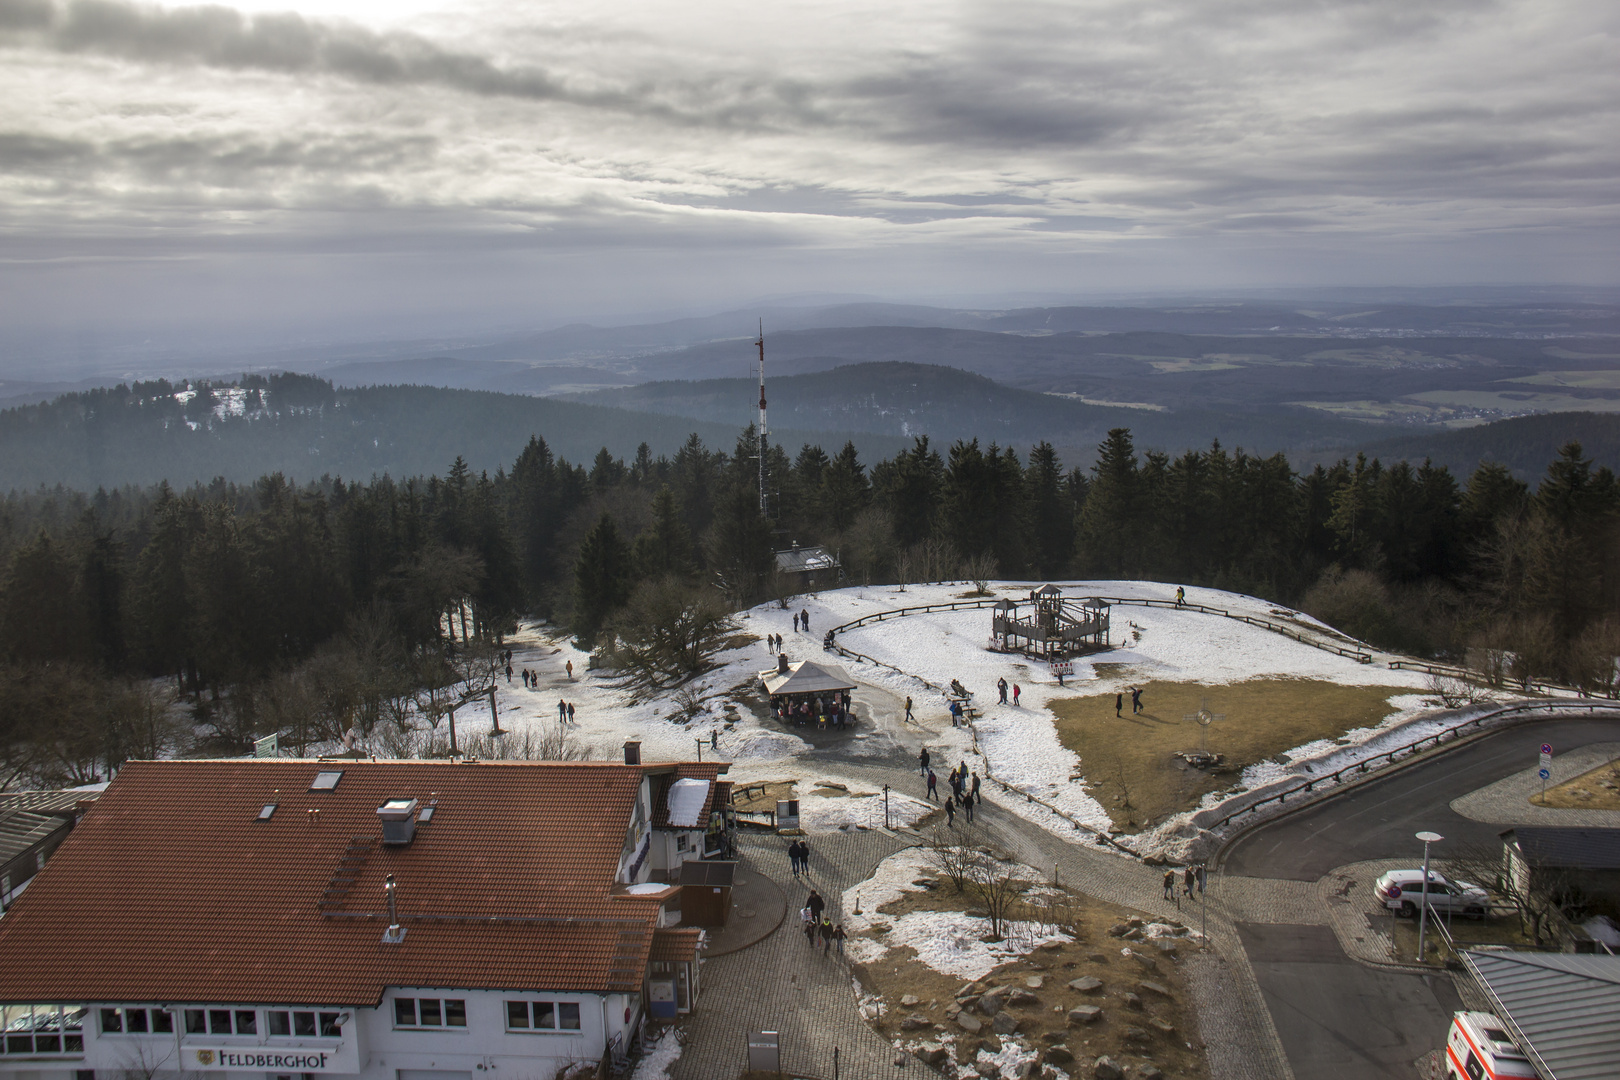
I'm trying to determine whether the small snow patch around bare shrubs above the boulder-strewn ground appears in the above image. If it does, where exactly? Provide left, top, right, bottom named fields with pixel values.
left=842, top=848, right=1072, bottom=981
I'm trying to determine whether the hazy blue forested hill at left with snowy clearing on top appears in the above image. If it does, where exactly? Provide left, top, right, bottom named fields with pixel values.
left=0, top=376, right=906, bottom=491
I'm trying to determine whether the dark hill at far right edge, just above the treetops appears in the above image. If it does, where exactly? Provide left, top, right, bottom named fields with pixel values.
left=1341, top=413, right=1620, bottom=481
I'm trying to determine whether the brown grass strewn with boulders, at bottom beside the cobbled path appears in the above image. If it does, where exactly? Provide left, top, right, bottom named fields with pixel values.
left=852, top=878, right=1207, bottom=1078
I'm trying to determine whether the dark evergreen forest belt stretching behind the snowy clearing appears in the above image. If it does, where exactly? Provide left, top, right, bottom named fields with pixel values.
left=0, top=417, right=1620, bottom=785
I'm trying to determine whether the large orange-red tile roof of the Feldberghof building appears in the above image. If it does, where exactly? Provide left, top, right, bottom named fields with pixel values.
left=0, top=759, right=693, bottom=1006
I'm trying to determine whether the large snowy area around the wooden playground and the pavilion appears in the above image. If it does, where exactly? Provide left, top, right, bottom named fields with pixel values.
left=440, top=581, right=1516, bottom=840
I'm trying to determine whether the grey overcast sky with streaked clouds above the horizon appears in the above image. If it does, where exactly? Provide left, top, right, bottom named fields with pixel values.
left=0, top=0, right=1620, bottom=362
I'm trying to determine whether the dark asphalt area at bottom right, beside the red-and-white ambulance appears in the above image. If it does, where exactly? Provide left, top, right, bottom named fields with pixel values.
left=1238, top=923, right=1463, bottom=1080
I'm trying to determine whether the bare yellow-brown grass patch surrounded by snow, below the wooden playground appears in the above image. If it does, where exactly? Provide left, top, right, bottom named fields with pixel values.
left=1051, top=680, right=1411, bottom=832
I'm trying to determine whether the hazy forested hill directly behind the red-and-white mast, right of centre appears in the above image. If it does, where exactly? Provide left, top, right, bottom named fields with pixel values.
left=580, top=363, right=1390, bottom=465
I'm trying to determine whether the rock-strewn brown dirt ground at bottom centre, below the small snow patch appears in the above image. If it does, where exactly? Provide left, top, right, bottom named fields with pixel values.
left=852, top=878, right=1207, bottom=1077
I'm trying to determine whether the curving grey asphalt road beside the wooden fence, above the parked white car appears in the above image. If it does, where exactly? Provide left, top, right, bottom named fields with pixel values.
left=1225, top=717, right=1620, bottom=881
